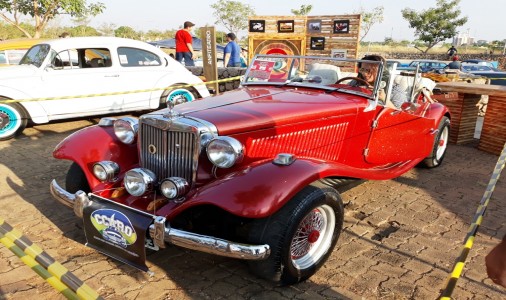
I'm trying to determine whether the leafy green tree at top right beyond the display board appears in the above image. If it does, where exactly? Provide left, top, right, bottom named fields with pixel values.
left=402, top=0, right=467, bottom=53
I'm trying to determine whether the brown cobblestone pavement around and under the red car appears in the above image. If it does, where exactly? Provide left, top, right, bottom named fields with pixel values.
left=0, top=120, right=506, bottom=299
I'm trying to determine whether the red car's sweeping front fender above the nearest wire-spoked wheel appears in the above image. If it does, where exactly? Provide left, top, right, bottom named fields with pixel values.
left=164, top=159, right=348, bottom=218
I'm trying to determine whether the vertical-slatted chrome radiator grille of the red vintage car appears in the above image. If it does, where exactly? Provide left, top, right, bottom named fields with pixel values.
left=139, top=123, right=198, bottom=185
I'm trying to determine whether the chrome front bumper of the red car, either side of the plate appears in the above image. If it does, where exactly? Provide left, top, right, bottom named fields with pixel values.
left=50, top=180, right=270, bottom=260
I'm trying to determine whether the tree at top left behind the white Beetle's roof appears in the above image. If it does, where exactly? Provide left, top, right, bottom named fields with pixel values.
left=0, top=0, right=105, bottom=38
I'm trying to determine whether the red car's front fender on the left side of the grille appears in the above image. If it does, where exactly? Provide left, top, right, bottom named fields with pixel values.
left=53, top=125, right=139, bottom=189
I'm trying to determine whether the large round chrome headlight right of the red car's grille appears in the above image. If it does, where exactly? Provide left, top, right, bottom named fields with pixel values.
left=206, top=136, right=244, bottom=168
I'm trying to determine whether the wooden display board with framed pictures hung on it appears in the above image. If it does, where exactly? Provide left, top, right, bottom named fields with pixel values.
left=248, top=15, right=361, bottom=60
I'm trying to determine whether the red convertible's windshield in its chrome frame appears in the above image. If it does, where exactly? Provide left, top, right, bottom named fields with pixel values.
left=242, top=55, right=388, bottom=99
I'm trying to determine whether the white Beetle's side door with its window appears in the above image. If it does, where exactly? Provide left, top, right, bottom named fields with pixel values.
left=38, top=49, right=124, bottom=119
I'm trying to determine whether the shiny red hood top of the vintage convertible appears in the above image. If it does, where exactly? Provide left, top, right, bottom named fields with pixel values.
left=154, top=87, right=367, bottom=135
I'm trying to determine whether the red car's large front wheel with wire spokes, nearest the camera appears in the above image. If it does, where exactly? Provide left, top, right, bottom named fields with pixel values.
left=249, top=186, right=344, bottom=284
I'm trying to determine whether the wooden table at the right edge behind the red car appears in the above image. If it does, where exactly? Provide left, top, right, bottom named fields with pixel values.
left=436, top=82, right=506, bottom=155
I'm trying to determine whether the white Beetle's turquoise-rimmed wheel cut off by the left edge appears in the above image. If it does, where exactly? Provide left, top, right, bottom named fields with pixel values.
left=0, top=102, right=28, bottom=141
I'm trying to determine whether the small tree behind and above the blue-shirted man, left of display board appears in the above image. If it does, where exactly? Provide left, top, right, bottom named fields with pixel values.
left=211, top=0, right=255, bottom=34
